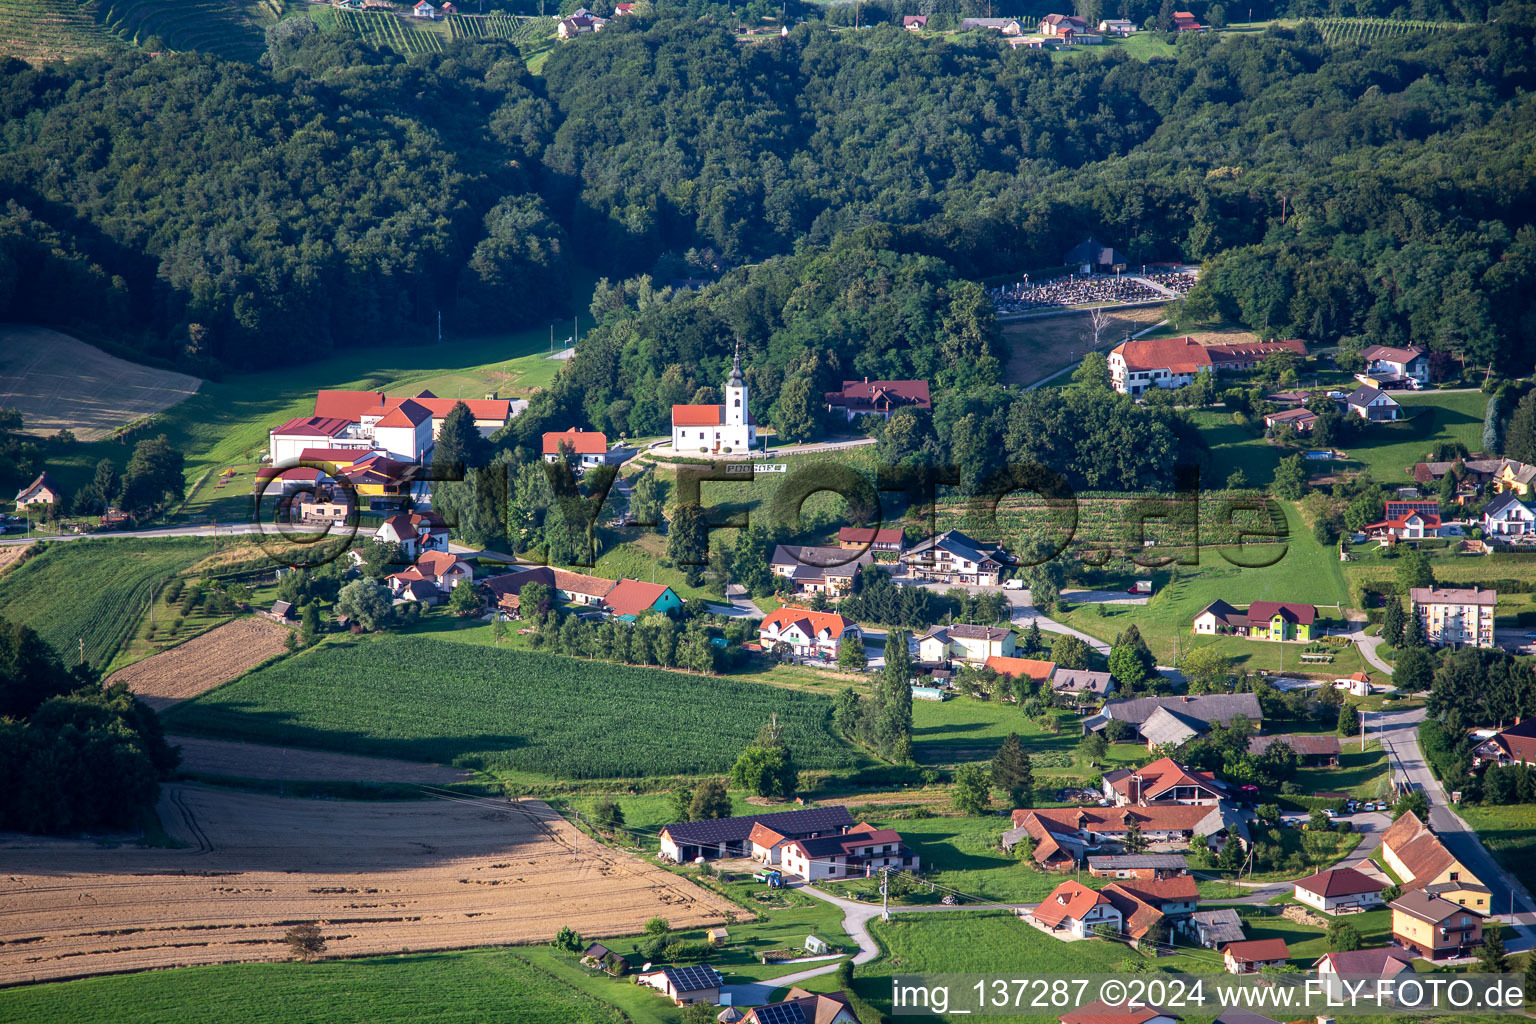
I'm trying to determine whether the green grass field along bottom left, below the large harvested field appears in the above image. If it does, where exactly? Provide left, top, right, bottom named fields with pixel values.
left=0, top=949, right=632, bottom=1024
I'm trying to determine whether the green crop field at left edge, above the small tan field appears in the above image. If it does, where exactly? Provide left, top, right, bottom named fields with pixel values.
left=0, top=539, right=210, bottom=668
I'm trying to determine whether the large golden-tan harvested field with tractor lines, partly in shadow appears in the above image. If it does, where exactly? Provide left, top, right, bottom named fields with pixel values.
left=0, top=785, right=734, bottom=986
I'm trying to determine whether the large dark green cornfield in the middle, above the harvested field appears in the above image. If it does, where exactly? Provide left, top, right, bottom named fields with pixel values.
left=166, top=636, right=859, bottom=778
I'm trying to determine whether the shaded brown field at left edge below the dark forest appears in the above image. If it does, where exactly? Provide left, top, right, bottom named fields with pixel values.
left=0, top=324, right=203, bottom=441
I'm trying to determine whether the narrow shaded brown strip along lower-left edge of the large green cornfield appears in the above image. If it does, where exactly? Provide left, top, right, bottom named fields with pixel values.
left=166, top=735, right=475, bottom=786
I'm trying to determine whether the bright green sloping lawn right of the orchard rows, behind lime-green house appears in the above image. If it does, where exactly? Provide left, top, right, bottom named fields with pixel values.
left=1060, top=502, right=1353, bottom=660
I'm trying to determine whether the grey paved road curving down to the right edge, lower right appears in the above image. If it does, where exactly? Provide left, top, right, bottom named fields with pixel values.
left=1370, top=708, right=1536, bottom=952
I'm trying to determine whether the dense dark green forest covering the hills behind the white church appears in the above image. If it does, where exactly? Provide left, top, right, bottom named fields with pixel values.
left=0, top=3, right=1536, bottom=376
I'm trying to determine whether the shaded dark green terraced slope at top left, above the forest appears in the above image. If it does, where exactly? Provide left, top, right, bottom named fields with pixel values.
left=100, top=0, right=270, bottom=60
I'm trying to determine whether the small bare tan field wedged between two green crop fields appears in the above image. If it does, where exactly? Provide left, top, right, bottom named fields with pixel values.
left=106, top=617, right=289, bottom=711
